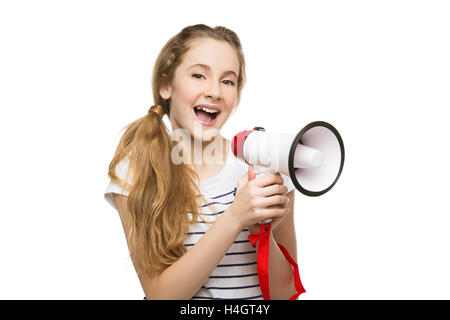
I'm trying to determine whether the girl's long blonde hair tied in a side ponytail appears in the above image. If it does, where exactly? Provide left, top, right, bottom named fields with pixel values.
left=108, top=24, right=246, bottom=276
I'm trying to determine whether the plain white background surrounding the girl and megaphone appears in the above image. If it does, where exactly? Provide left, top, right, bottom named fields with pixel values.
left=0, top=0, right=450, bottom=299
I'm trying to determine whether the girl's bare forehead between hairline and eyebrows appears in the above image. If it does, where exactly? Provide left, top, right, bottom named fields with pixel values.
left=182, top=38, right=239, bottom=74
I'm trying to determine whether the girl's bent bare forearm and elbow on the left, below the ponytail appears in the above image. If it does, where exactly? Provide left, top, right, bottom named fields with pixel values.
left=114, top=194, right=241, bottom=300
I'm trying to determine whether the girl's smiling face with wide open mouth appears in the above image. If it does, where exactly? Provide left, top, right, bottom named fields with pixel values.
left=160, top=38, right=239, bottom=141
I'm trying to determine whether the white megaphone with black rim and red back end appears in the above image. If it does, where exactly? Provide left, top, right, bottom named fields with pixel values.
left=231, top=121, right=345, bottom=197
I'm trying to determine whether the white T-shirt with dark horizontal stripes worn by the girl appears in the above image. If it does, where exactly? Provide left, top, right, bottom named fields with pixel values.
left=105, top=152, right=294, bottom=300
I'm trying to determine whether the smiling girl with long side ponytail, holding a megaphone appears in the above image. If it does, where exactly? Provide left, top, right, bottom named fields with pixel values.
left=105, top=24, right=296, bottom=299
